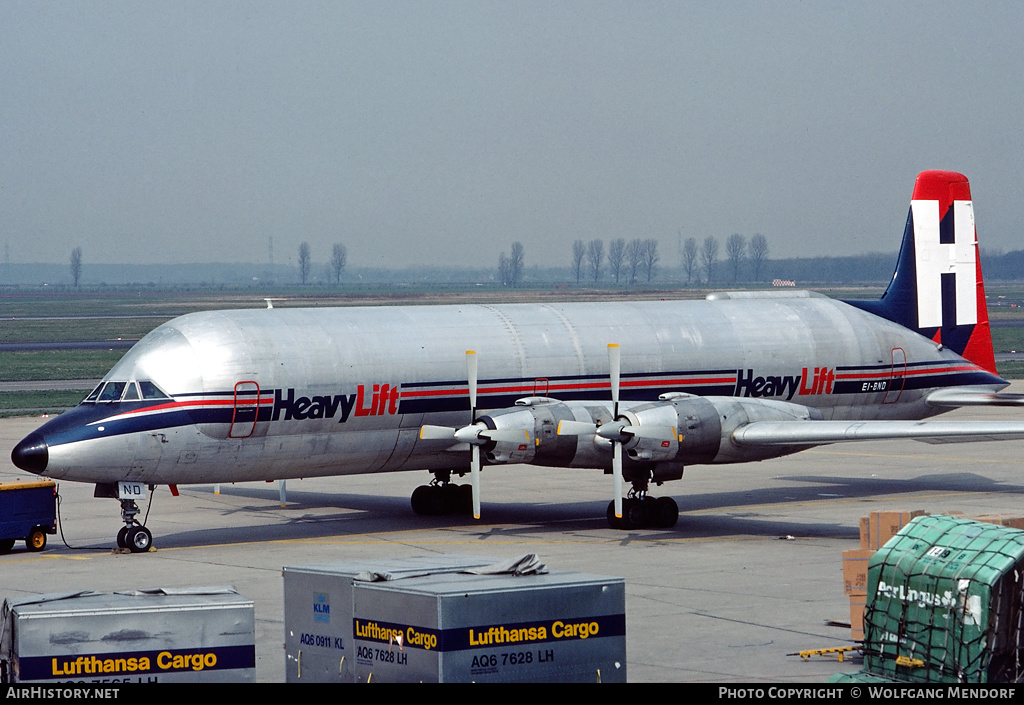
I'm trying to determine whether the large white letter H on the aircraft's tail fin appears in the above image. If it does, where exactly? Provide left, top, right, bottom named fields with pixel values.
left=910, top=201, right=978, bottom=328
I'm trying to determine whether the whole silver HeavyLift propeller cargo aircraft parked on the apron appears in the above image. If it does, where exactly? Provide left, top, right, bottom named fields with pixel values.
left=11, top=171, right=1024, bottom=550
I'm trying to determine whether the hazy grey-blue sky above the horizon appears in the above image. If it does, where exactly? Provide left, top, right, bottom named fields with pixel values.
left=0, top=0, right=1024, bottom=266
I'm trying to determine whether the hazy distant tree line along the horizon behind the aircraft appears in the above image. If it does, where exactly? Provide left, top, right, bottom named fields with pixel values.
left=49, top=234, right=1024, bottom=288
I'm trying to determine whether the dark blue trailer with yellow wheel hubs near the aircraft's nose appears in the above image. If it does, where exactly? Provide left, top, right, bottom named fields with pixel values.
left=0, top=481, right=57, bottom=553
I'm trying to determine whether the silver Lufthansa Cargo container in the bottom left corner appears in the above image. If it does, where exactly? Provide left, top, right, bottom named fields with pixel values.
left=0, top=587, right=256, bottom=683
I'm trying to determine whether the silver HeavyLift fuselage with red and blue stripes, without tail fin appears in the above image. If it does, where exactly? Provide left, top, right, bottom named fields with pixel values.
left=29, top=292, right=1004, bottom=484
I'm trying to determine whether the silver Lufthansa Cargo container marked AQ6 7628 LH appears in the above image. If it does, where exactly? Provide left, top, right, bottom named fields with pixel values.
left=352, top=571, right=626, bottom=682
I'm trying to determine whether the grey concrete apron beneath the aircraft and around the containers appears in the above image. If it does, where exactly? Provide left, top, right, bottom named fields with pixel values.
left=0, top=389, right=1024, bottom=682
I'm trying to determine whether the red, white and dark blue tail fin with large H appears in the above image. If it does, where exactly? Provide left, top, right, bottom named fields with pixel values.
left=850, top=171, right=997, bottom=374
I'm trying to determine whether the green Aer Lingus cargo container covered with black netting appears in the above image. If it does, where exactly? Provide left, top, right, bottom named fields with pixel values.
left=863, top=515, right=1024, bottom=682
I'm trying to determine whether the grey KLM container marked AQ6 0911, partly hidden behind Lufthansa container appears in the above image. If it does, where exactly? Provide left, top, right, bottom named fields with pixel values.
left=282, top=554, right=499, bottom=682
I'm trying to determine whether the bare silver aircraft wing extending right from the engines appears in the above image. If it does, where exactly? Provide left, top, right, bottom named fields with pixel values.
left=732, top=420, right=1024, bottom=446
